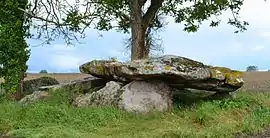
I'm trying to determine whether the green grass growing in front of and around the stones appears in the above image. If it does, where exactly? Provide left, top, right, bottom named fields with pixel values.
left=0, top=91, right=270, bottom=138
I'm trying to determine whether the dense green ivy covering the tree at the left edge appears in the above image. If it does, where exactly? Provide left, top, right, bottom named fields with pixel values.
left=0, top=0, right=30, bottom=96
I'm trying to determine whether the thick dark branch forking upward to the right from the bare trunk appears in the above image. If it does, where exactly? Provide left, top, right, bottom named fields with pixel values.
left=143, top=0, right=164, bottom=26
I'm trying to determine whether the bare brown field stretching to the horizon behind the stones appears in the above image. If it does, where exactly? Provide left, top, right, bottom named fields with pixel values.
left=0, top=72, right=270, bottom=91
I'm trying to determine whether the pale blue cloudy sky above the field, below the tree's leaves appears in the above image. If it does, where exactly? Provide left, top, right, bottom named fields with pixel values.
left=27, top=0, right=270, bottom=73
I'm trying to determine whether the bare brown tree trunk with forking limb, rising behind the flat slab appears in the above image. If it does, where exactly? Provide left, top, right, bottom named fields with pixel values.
left=130, top=0, right=164, bottom=60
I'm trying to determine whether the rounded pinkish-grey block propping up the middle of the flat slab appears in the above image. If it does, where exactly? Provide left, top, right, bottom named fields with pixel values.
left=118, top=81, right=172, bottom=112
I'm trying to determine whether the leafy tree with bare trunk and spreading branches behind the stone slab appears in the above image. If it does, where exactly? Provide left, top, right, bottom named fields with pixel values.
left=21, top=0, right=248, bottom=60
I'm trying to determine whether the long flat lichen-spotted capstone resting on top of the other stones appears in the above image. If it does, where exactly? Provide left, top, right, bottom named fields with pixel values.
left=80, top=55, right=244, bottom=92
